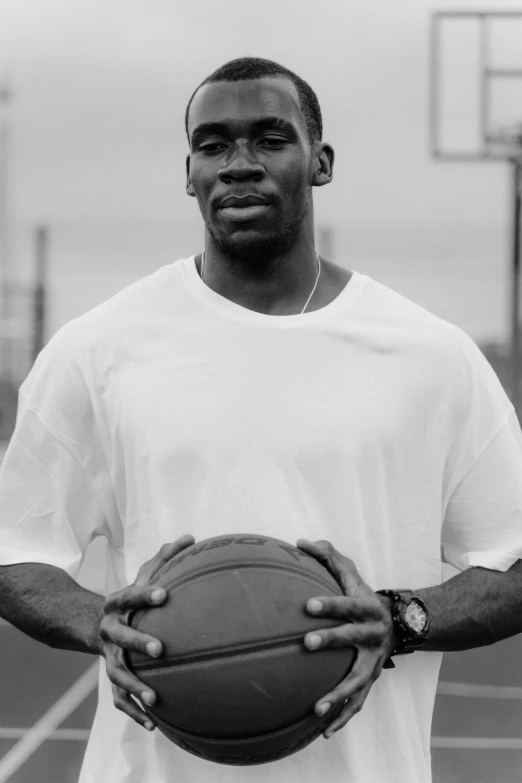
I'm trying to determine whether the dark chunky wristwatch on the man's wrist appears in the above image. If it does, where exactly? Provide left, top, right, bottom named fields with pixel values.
left=376, top=589, right=430, bottom=668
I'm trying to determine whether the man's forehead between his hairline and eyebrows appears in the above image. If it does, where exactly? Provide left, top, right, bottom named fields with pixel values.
left=188, top=77, right=304, bottom=134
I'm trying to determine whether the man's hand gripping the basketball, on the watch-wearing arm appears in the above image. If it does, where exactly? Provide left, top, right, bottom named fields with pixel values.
left=297, top=538, right=395, bottom=739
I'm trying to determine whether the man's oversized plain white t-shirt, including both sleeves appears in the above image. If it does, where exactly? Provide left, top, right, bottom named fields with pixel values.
left=0, top=256, right=522, bottom=783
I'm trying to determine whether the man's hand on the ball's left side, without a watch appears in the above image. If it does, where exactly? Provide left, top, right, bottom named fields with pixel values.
left=100, top=535, right=195, bottom=731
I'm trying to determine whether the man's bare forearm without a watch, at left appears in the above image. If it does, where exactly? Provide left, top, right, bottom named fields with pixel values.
left=0, top=563, right=105, bottom=655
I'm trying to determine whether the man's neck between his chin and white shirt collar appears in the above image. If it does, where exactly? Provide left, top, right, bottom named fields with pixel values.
left=199, top=251, right=321, bottom=315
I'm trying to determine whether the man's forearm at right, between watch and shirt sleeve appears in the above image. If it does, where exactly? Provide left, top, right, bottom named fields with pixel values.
left=415, top=560, right=522, bottom=651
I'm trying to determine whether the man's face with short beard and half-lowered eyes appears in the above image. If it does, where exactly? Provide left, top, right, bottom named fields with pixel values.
left=187, top=78, right=322, bottom=261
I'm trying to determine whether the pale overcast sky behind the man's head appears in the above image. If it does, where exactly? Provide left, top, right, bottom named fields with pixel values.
left=0, top=0, right=522, bottom=231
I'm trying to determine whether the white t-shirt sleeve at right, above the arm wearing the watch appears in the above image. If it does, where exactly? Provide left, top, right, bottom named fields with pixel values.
left=442, top=328, right=522, bottom=571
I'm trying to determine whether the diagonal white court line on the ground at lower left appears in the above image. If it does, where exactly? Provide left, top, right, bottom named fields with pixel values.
left=0, top=661, right=100, bottom=783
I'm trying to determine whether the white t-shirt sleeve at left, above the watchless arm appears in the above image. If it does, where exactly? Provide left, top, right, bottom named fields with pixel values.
left=0, top=330, right=118, bottom=578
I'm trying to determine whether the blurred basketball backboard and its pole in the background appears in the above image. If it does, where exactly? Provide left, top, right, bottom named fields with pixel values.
left=428, top=10, right=522, bottom=415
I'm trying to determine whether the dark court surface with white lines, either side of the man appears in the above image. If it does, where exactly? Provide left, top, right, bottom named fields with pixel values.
left=0, top=444, right=522, bottom=783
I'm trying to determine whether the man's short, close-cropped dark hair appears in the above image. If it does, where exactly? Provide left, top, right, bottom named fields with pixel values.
left=185, top=57, right=323, bottom=147
